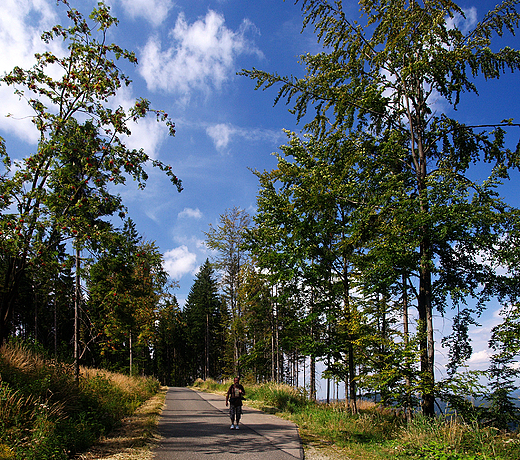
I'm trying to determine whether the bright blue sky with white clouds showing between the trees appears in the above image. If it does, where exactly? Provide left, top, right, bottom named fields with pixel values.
left=0, top=0, right=520, bottom=388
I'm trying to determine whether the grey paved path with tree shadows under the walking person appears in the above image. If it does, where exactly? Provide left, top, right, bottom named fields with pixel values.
left=154, top=388, right=303, bottom=460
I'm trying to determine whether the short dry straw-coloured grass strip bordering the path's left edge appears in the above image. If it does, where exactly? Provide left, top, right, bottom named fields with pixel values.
left=78, top=387, right=167, bottom=460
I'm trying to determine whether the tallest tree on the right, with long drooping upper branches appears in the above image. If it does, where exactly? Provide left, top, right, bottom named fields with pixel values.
left=242, top=0, right=520, bottom=415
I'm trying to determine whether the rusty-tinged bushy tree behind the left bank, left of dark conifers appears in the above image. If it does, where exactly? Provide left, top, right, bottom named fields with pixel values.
left=87, top=220, right=167, bottom=373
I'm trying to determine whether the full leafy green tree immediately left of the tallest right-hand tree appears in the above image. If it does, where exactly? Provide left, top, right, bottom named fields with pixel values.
left=251, top=133, right=398, bottom=411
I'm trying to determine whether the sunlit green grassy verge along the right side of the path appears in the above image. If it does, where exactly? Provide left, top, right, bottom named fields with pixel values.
left=194, top=380, right=520, bottom=460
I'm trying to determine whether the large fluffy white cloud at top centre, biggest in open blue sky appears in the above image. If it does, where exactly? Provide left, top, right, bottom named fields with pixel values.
left=139, top=10, right=260, bottom=103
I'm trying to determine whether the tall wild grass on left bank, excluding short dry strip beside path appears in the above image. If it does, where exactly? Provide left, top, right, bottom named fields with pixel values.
left=0, top=345, right=159, bottom=460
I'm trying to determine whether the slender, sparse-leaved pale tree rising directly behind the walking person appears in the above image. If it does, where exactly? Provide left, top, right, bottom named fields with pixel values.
left=205, top=207, right=251, bottom=375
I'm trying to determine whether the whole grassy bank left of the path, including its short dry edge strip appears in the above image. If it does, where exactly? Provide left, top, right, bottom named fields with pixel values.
left=0, top=344, right=165, bottom=460
